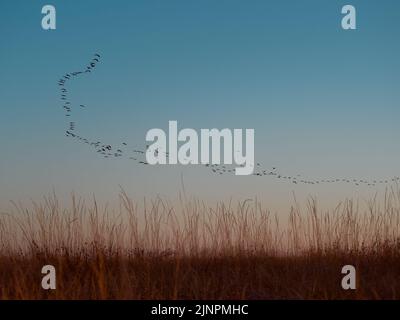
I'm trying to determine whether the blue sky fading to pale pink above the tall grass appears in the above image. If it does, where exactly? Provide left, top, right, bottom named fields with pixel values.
left=0, top=0, right=400, bottom=214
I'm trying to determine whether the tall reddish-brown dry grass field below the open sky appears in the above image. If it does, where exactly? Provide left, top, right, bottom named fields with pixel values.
left=0, top=187, right=400, bottom=299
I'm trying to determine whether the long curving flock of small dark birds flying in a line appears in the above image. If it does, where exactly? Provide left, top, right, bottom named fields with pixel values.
left=58, top=53, right=400, bottom=186
